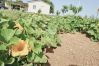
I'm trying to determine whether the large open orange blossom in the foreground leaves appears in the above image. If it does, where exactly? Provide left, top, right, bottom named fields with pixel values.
left=10, top=40, right=30, bottom=57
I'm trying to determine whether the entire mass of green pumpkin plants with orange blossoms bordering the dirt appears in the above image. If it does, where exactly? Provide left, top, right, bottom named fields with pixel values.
left=0, top=11, right=99, bottom=66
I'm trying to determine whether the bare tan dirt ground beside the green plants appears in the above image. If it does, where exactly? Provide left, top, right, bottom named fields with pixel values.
left=47, top=33, right=99, bottom=66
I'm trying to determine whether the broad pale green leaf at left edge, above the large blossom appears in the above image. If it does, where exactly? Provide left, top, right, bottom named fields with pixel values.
left=0, top=29, right=15, bottom=42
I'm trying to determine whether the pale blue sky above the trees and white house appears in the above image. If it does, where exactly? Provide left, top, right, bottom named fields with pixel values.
left=23, top=0, right=99, bottom=16
